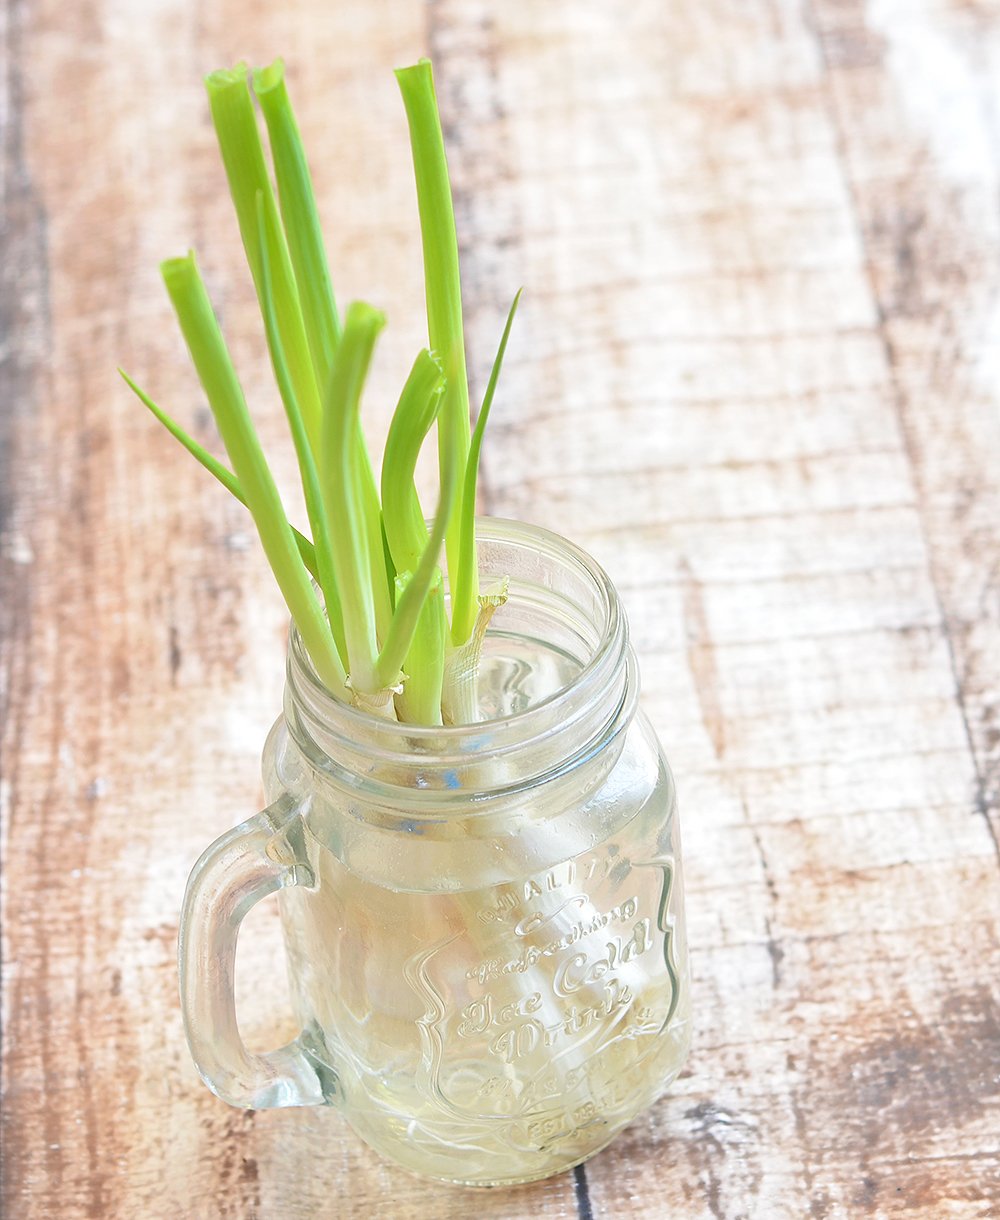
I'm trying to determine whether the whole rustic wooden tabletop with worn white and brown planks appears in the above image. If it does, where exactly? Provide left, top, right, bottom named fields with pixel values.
left=0, top=0, right=1000, bottom=1220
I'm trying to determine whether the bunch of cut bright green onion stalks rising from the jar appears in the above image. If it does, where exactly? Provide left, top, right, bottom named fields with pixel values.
left=120, top=60, right=520, bottom=725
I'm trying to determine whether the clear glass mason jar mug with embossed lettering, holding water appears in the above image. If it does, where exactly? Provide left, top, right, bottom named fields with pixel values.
left=180, top=520, right=690, bottom=1186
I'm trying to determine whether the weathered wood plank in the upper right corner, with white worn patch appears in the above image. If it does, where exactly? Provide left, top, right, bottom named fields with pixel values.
left=816, top=0, right=1000, bottom=854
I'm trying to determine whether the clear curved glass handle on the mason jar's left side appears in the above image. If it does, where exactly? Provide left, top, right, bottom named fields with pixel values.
left=178, top=794, right=327, bottom=1110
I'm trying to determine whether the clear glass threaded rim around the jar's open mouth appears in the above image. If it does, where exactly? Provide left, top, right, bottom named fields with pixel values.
left=288, top=516, right=628, bottom=756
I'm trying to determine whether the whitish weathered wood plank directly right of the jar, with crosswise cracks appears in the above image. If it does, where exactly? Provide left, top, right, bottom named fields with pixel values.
left=463, top=2, right=1000, bottom=1218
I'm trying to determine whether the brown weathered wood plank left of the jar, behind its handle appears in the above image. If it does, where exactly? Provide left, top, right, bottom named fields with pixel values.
left=4, top=2, right=576, bottom=1218
